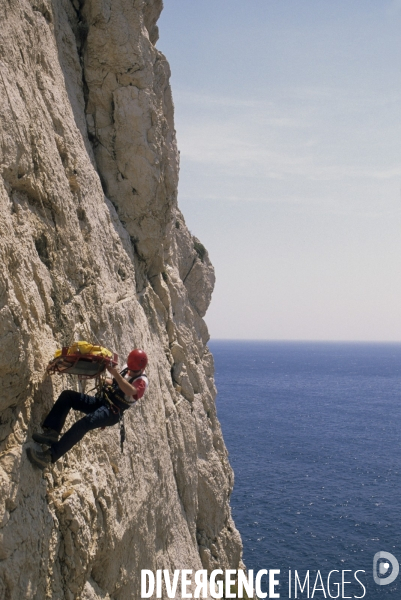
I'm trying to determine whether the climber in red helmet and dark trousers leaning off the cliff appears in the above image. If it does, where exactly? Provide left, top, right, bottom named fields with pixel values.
left=27, top=348, right=149, bottom=469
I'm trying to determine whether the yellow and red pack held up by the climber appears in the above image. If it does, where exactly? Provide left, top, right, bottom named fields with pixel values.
left=47, top=341, right=118, bottom=379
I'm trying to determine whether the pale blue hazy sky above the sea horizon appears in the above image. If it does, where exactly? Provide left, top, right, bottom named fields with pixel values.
left=157, top=0, right=401, bottom=341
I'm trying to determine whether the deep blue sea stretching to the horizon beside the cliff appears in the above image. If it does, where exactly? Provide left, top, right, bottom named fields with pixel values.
left=209, top=340, right=401, bottom=600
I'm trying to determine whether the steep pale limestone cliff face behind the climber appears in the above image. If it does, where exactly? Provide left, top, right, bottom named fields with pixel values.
left=0, top=0, right=241, bottom=600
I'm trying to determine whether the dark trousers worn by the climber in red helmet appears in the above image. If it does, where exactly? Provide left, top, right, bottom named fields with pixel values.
left=43, top=390, right=119, bottom=462
